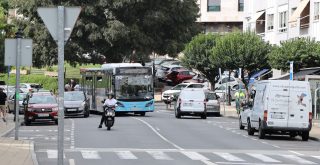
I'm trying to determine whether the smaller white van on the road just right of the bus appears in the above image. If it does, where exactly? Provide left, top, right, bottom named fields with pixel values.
left=175, top=88, right=207, bottom=119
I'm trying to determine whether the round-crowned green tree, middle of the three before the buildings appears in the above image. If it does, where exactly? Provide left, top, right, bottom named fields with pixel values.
left=212, top=31, right=271, bottom=88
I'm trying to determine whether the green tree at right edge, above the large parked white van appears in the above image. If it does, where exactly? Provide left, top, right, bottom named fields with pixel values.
left=268, top=38, right=320, bottom=71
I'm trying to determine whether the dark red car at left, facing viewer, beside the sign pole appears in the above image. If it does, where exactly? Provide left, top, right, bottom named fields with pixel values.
left=23, top=93, right=58, bottom=125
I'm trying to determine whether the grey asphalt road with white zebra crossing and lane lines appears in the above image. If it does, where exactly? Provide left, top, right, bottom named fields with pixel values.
left=8, top=103, right=320, bottom=165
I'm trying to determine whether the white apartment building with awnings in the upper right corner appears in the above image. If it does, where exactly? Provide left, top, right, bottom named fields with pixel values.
left=243, top=0, right=320, bottom=44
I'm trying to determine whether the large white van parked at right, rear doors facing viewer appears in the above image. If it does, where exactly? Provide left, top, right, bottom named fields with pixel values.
left=248, top=80, right=312, bottom=141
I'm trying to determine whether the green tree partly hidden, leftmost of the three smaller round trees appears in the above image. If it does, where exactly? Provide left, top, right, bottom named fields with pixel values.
left=181, top=34, right=221, bottom=89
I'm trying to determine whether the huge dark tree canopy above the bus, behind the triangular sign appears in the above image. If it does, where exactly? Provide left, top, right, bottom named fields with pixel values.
left=10, top=0, right=199, bottom=67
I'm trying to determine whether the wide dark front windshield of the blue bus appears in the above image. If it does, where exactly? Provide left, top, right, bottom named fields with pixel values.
left=115, top=75, right=153, bottom=100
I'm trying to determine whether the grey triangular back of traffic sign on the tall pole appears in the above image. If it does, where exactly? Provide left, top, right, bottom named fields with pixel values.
left=37, top=7, right=81, bottom=41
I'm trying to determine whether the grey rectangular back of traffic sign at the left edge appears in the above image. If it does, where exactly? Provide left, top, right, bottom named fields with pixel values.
left=4, top=39, right=32, bottom=66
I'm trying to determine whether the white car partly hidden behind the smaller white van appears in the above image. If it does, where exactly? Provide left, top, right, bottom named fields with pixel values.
left=161, top=83, right=205, bottom=104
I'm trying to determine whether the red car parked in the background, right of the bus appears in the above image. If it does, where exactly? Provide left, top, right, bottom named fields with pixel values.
left=166, top=70, right=196, bottom=85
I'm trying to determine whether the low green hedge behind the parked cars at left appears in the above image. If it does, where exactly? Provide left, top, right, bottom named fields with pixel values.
left=0, top=74, right=58, bottom=90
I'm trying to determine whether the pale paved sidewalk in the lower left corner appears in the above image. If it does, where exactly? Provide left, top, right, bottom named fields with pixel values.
left=0, top=114, right=38, bottom=165
